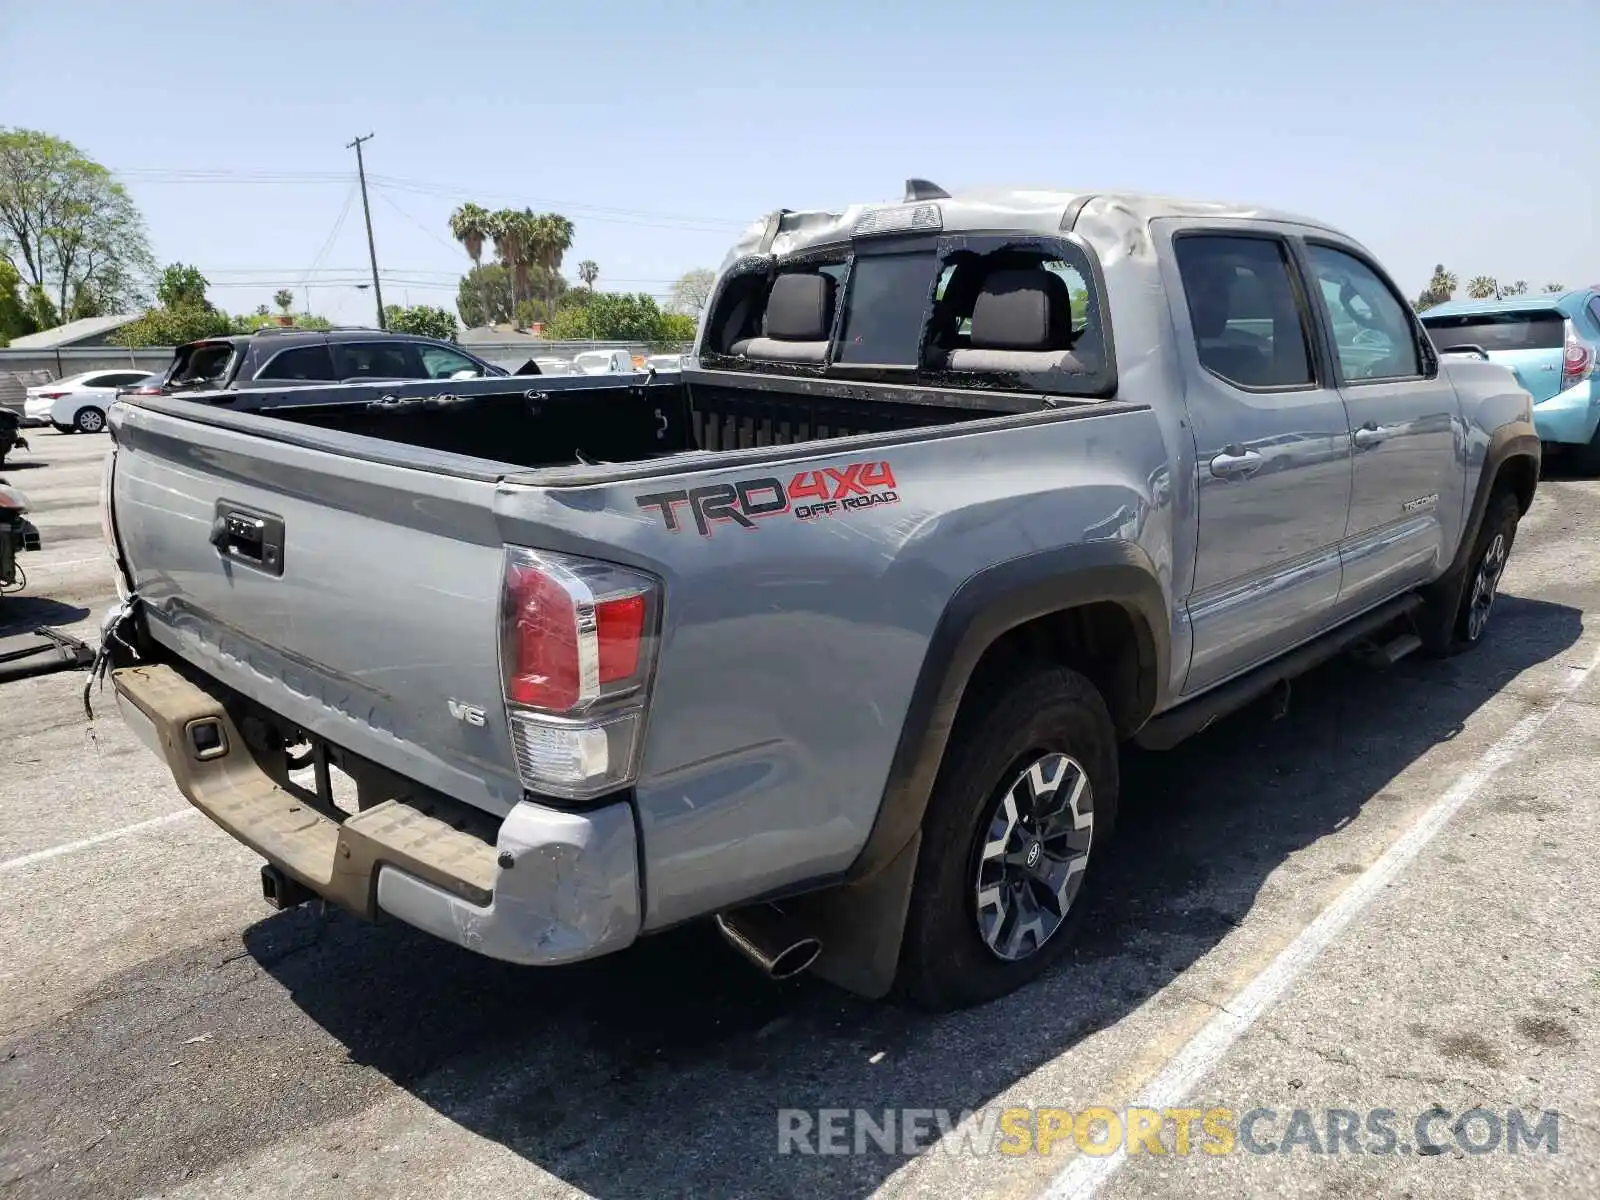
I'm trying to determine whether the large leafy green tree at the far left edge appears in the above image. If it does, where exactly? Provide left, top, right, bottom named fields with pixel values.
left=0, top=128, right=155, bottom=314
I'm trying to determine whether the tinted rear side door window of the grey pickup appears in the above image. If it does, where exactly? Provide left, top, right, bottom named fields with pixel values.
left=1173, top=235, right=1312, bottom=387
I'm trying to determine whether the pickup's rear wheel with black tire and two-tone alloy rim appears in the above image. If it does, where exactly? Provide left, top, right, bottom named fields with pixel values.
left=896, top=667, right=1118, bottom=1010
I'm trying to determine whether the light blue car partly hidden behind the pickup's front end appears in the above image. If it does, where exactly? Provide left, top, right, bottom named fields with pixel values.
left=1422, top=285, right=1600, bottom=472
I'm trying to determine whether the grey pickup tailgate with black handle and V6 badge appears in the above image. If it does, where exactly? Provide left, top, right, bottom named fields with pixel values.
left=112, top=400, right=522, bottom=814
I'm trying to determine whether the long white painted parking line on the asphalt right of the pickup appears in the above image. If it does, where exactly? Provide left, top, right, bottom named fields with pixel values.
left=1042, top=633, right=1600, bottom=1200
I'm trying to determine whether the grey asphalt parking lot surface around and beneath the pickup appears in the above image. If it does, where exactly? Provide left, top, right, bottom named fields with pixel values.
left=0, top=430, right=1600, bottom=1200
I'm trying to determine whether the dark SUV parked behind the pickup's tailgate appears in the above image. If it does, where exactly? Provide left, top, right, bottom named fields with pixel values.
left=152, top=326, right=509, bottom=394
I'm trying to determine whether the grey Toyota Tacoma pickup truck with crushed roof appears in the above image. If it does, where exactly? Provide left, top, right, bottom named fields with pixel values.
left=106, top=181, right=1539, bottom=1006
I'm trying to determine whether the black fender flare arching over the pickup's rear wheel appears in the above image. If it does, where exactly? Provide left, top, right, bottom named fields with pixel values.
left=846, top=541, right=1171, bottom=880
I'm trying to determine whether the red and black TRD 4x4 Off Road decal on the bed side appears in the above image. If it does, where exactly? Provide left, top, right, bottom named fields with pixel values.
left=634, top=462, right=899, bottom=538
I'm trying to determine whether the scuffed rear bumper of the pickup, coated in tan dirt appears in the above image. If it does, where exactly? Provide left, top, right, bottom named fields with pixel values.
left=112, top=666, right=642, bottom=965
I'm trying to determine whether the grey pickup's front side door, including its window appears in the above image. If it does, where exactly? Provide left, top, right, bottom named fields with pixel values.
left=1302, top=238, right=1466, bottom=616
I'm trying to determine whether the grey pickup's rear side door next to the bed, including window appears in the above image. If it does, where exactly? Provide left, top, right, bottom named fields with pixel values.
left=1155, top=221, right=1350, bottom=693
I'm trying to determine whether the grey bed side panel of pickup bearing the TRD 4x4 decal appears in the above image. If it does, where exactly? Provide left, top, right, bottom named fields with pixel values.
left=499, top=405, right=1173, bottom=928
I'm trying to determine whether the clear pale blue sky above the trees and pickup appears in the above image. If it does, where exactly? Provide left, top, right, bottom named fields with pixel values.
left=0, top=0, right=1600, bottom=320
